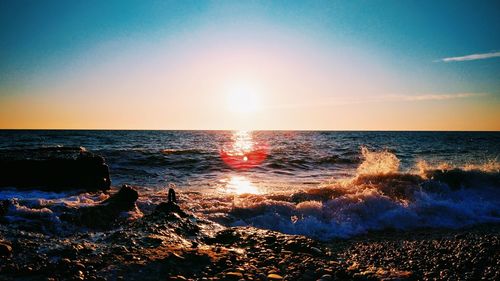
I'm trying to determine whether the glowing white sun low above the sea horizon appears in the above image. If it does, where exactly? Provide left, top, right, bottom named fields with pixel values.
left=226, top=83, right=260, bottom=114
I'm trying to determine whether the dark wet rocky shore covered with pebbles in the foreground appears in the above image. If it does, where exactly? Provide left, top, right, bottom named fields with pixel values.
left=0, top=186, right=500, bottom=280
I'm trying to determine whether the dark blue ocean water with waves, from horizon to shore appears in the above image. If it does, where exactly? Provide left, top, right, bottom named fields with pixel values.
left=0, top=131, right=500, bottom=240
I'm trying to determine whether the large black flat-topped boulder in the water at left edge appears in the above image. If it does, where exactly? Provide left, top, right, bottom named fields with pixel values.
left=0, top=147, right=111, bottom=191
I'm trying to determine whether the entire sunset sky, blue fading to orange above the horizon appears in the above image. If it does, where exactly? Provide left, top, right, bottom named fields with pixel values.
left=0, top=0, right=500, bottom=130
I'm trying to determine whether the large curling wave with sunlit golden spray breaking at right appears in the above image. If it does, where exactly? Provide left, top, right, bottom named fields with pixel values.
left=187, top=145, right=500, bottom=240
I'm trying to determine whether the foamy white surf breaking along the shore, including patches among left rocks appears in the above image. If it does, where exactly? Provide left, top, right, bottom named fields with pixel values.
left=0, top=148, right=500, bottom=240
